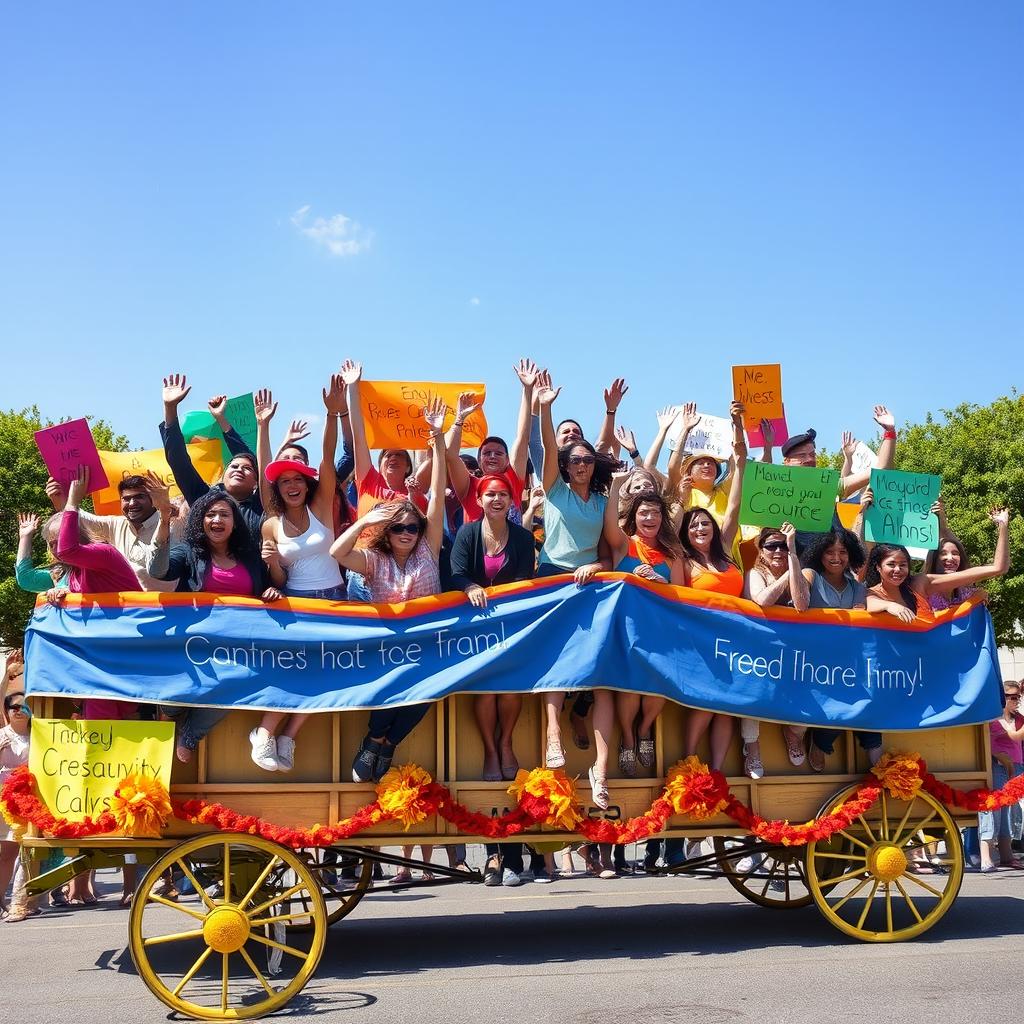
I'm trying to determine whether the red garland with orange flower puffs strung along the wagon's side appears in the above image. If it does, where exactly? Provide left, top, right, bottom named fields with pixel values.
left=0, top=753, right=1024, bottom=849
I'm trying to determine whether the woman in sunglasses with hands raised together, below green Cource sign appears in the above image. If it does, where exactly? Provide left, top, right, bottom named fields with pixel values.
left=739, top=522, right=809, bottom=779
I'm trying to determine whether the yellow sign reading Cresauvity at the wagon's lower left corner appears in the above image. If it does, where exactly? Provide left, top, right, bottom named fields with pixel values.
left=29, top=718, right=174, bottom=821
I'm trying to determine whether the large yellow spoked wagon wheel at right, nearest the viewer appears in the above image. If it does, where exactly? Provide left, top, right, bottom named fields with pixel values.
left=807, top=785, right=964, bottom=942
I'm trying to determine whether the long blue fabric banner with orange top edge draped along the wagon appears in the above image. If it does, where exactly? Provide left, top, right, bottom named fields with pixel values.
left=26, top=573, right=1001, bottom=730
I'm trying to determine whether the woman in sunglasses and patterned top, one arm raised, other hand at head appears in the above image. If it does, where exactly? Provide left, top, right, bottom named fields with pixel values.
left=331, top=398, right=447, bottom=782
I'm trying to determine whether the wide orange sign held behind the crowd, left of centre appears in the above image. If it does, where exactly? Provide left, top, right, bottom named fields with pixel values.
left=359, top=381, right=487, bottom=449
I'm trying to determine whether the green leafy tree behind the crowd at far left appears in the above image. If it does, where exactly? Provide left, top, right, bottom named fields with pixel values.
left=0, top=406, right=128, bottom=647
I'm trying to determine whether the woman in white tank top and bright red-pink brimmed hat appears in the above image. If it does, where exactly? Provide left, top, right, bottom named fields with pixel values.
left=249, top=375, right=347, bottom=771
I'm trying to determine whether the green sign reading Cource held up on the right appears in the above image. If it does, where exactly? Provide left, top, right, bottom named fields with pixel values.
left=739, top=462, right=839, bottom=534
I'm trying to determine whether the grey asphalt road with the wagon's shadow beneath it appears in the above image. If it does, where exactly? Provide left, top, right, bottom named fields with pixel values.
left=8, top=856, right=1024, bottom=1024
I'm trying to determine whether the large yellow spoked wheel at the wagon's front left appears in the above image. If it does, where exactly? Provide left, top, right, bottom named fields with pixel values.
left=128, top=834, right=327, bottom=1020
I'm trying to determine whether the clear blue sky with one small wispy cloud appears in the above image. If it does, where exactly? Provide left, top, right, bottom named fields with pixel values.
left=0, top=2, right=1024, bottom=460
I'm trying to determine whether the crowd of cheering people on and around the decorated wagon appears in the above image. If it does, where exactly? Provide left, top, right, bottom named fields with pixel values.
left=0, top=359, right=1024, bottom=898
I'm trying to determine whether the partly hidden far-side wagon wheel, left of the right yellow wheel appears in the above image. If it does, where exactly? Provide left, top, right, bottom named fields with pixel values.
left=715, top=836, right=814, bottom=909
